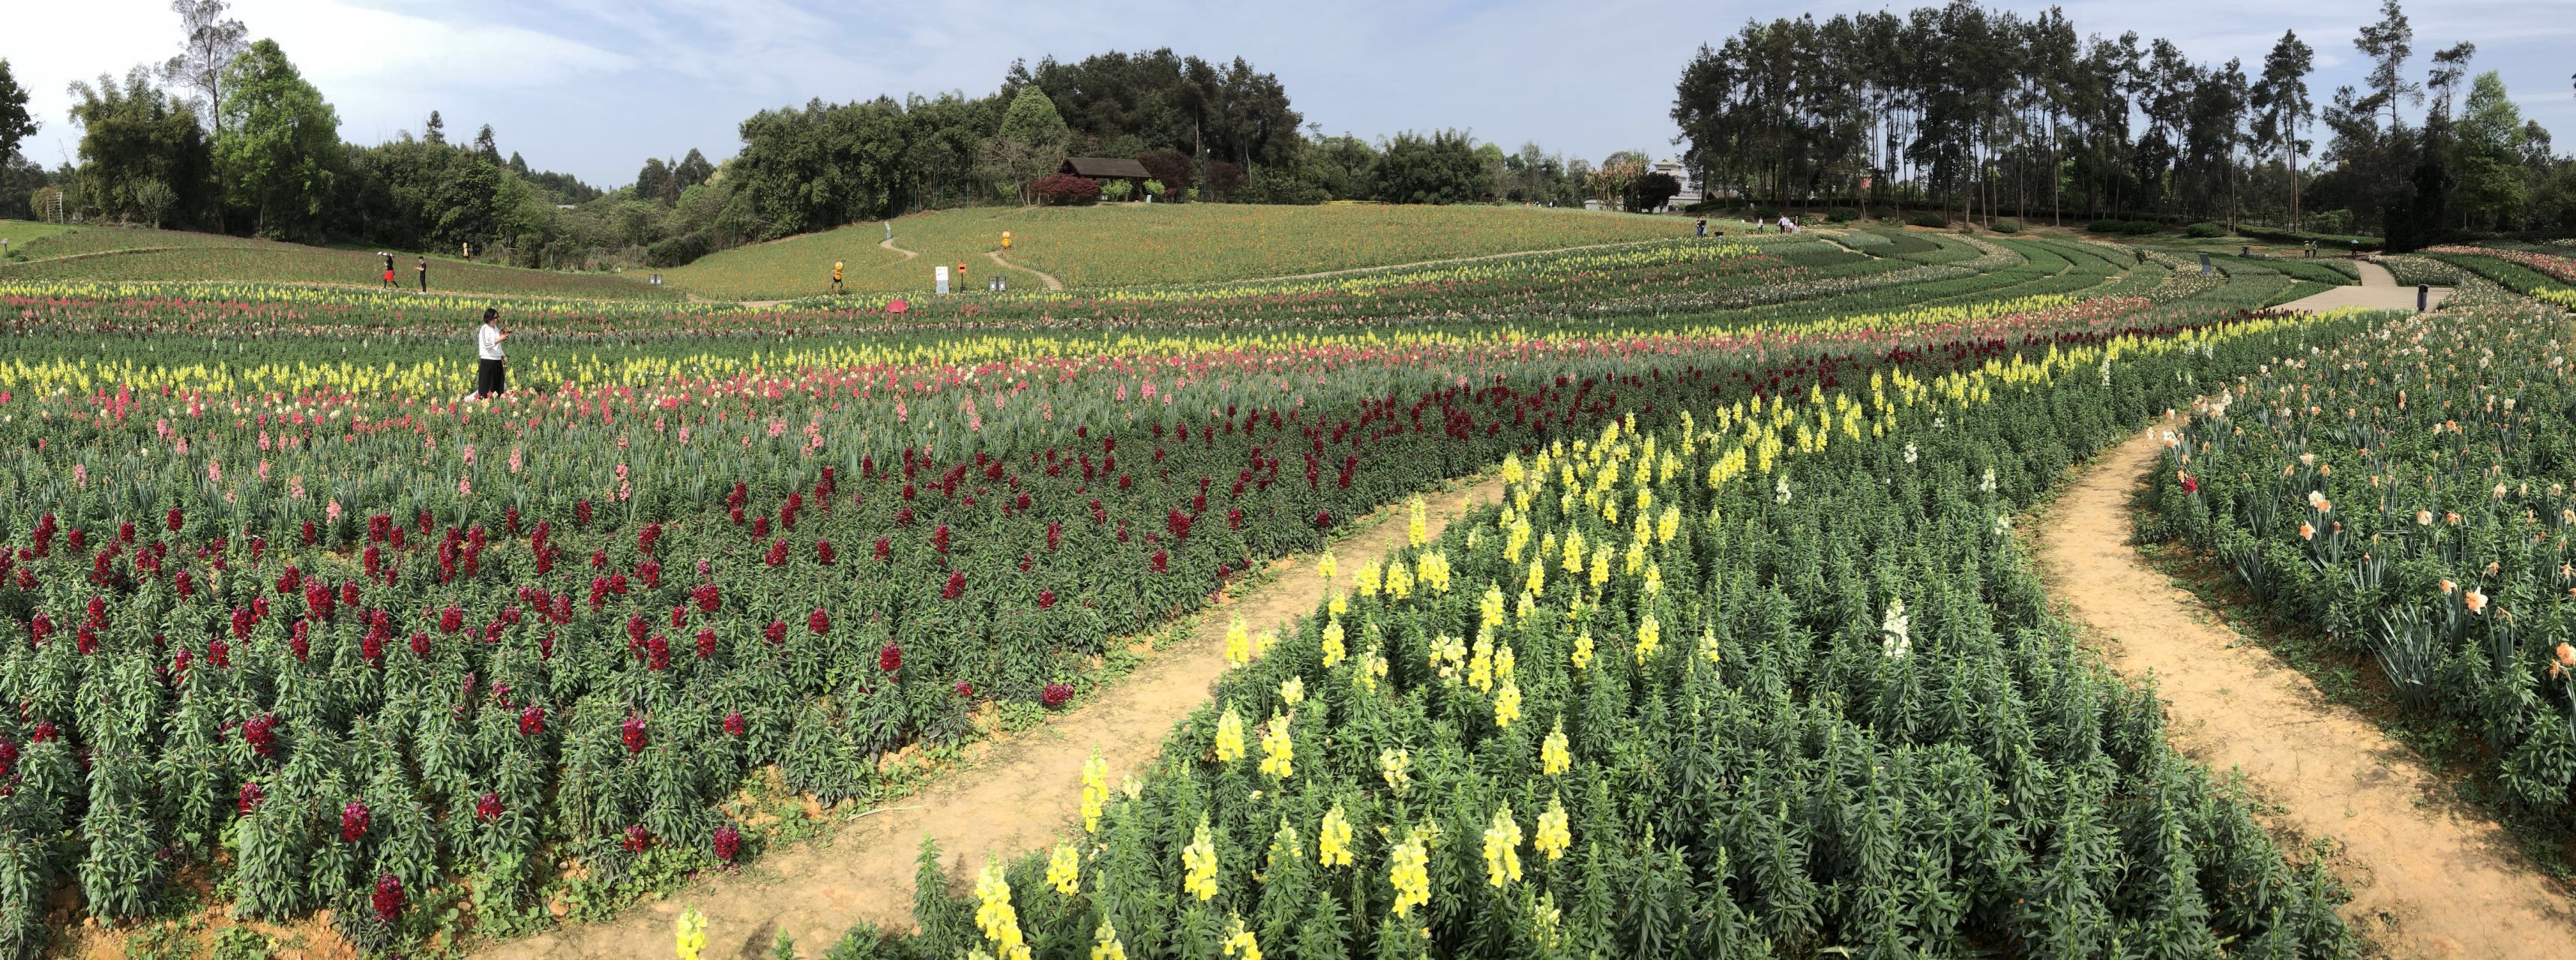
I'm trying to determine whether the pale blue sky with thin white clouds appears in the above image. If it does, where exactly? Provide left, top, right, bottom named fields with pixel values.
left=0, top=0, right=2576, bottom=188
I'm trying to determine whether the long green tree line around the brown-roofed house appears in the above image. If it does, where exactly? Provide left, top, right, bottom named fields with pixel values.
left=0, top=0, right=1679, bottom=268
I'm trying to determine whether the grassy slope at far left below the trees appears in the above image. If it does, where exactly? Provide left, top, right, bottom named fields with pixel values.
left=0, top=221, right=683, bottom=298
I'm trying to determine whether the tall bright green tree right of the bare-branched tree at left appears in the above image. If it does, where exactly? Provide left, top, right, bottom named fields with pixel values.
left=214, top=38, right=345, bottom=234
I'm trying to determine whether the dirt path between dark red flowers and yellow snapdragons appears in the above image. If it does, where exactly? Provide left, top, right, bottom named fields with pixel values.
left=484, top=473, right=1505, bottom=960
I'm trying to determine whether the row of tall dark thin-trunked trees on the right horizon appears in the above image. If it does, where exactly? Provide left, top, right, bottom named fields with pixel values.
left=1672, top=0, right=2576, bottom=247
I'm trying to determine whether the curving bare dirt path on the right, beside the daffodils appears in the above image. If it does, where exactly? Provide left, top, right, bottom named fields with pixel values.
left=2038, top=422, right=2576, bottom=958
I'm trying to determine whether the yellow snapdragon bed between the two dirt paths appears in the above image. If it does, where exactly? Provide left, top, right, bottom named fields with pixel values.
left=881, top=302, right=2359, bottom=958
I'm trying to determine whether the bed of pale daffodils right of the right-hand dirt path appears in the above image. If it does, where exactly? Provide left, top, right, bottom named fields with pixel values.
left=2149, top=280, right=2576, bottom=821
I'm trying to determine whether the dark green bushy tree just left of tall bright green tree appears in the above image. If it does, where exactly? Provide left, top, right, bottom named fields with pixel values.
left=64, top=67, right=211, bottom=226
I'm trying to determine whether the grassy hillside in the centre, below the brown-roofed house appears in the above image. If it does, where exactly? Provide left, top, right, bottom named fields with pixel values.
left=662, top=203, right=1690, bottom=298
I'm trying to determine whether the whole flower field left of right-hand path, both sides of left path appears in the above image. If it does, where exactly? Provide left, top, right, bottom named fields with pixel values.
left=0, top=237, right=2390, bottom=955
